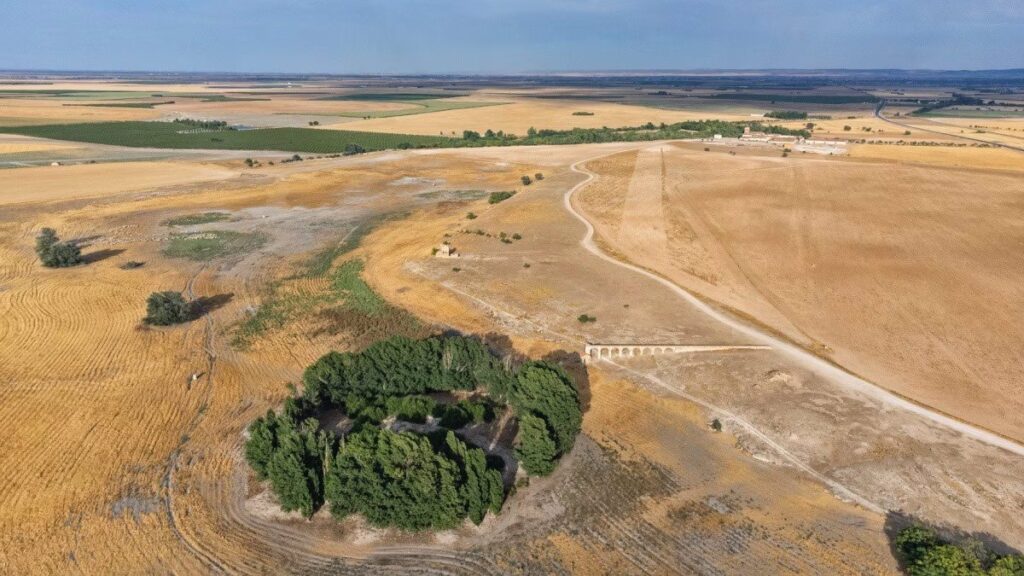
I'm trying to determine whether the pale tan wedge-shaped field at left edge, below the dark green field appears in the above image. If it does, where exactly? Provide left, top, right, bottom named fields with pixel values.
left=0, top=162, right=240, bottom=205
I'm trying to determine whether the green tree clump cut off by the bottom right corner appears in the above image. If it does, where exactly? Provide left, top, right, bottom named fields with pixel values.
left=894, top=526, right=1024, bottom=576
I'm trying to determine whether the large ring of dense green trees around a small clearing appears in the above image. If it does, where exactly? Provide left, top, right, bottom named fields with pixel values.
left=245, top=335, right=583, bottom=530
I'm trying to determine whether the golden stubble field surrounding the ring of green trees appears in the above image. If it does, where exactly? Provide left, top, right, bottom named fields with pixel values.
left=0, top=140, right=942, bottom=574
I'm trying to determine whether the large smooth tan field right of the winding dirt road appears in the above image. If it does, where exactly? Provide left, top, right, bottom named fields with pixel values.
left=581, top=142, right=1024, bottom=439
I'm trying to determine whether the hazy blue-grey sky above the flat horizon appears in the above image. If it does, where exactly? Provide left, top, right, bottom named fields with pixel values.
left=0, top=0, right=1024, bottom=73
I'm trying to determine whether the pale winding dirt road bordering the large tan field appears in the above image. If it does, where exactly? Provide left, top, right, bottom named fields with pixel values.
left=562, top=146, right=1024, bottom=456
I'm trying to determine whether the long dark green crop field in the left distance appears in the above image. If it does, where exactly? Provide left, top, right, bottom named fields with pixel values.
left=0, top=122, right=447, bottom=154
